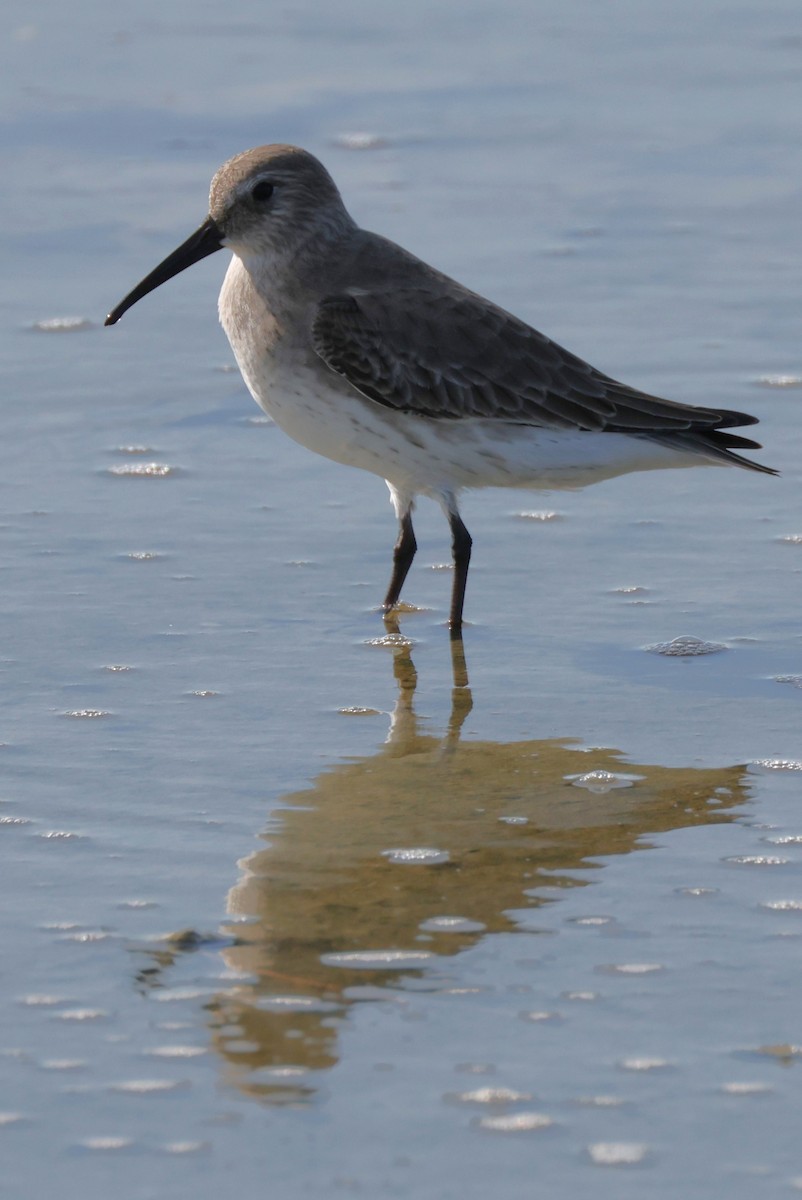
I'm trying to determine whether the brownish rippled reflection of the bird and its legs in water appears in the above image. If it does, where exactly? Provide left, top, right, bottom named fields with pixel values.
left=141, top=626, right=744, bottom=1102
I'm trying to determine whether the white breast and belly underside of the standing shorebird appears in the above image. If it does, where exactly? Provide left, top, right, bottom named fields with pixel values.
left=219, top=257, right=705, bottom=497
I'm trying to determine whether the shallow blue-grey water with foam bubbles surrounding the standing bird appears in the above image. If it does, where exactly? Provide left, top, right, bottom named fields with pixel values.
left=0, top=0, right=802, bottom=1200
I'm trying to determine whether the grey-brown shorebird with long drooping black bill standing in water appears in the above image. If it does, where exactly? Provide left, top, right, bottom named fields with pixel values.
left=106, top=145, right=777, bottom=637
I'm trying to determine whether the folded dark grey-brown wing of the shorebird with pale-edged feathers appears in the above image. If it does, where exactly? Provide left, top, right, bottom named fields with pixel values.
left=312, top=281, right=754, bottom=436
